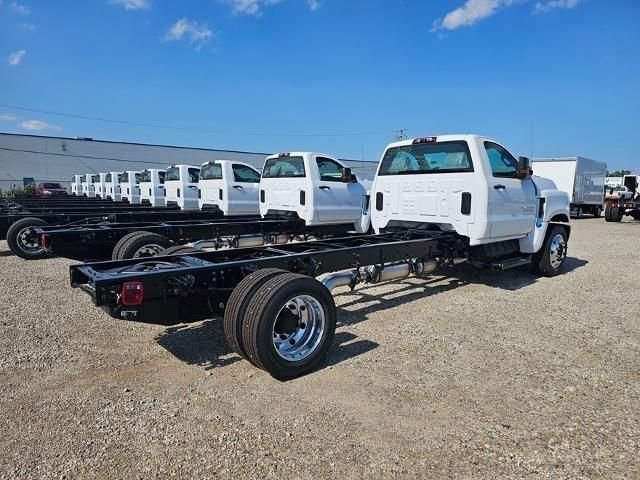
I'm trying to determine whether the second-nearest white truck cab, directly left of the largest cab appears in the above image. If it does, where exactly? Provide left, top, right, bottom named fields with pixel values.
left=260, top=152, right=369, bottom=232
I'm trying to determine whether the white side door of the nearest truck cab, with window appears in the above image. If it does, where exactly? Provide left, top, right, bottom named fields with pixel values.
left=484, top=142, right=536, bottom=239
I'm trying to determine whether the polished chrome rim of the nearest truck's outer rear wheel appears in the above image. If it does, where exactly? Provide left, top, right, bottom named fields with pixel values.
left=272, top=295, right=326, bottom=362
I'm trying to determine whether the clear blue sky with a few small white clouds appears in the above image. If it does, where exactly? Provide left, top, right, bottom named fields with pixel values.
left=0, top=0, right=640, bottom=170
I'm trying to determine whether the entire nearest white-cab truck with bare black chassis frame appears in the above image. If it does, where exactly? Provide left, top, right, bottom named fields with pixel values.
left=70, top=135, right=570, bottom=380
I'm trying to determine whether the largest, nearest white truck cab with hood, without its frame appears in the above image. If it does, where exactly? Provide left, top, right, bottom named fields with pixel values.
left=371, top=135, right=569, bottom=256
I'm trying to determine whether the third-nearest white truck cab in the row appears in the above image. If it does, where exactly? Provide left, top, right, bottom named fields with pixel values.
left=199, top=160, right=260, bottom=216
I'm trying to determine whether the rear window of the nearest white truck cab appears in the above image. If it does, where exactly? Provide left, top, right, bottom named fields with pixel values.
left=378, top=141, right=473, bottom=175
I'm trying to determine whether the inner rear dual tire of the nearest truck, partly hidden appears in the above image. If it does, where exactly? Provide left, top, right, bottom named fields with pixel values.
left=224, top=268, right=289, bottom=363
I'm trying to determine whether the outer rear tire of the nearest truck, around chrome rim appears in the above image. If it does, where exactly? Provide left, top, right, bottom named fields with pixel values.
left=242, top=273, right=336, bottom=380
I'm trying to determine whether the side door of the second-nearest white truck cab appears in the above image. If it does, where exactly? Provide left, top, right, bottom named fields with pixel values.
left=313, top=157, right=363, bottom=224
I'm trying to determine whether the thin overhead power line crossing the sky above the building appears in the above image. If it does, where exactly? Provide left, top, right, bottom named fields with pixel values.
left=0, top=103, right=393, bottom=137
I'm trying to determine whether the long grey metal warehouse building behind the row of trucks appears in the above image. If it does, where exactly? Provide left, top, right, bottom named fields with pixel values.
left=0, top=133, right=377, bottom=190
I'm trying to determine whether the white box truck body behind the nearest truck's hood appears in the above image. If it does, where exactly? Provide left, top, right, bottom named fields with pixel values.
left=533, top=157, right=607, bottom=218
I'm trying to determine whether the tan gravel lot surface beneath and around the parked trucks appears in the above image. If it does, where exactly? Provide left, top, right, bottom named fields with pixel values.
left=0, top=219, right=640, bottom=479
